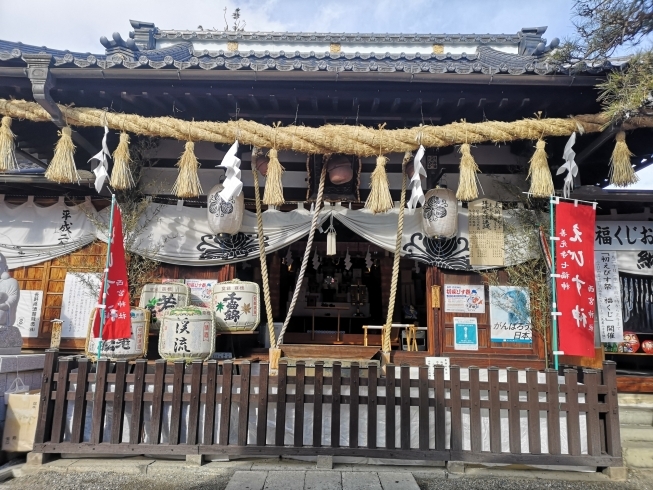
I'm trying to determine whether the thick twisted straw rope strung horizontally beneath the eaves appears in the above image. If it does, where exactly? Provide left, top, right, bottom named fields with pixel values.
left=5, top=99, right=653, bottom=157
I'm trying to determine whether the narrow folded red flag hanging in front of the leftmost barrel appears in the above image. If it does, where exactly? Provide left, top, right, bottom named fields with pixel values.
left=93, top=204, right=131, bottom=340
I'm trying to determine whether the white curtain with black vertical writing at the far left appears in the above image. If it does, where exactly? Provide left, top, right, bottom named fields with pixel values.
left=0, top=196, right=97, bottom=269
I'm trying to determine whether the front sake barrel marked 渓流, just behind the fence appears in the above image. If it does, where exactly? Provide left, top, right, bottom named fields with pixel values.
left=159, top=306, right=215, bottom=361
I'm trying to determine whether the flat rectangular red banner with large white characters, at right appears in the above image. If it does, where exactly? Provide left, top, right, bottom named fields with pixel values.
left=555, top=202, right=596, bottom=357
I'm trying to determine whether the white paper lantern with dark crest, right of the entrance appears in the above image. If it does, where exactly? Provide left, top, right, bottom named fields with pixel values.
left=422, top=187, right=458, bottom=238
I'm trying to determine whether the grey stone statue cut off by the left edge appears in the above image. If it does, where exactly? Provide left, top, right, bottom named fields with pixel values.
left=0, top=253, right=23, bottom=355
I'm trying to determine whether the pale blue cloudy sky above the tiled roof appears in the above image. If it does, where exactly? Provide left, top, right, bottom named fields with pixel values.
left=0, top=0, right=574, bottom=53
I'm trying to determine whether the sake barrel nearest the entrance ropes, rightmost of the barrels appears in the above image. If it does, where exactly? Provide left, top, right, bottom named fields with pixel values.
left=211, top=279, right=261, bottom=331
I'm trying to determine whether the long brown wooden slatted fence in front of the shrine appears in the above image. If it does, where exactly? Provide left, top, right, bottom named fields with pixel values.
left=34, top=350, right=622, bottom=467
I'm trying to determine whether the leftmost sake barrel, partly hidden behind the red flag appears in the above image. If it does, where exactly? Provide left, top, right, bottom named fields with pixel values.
left=86, top=307, right=150, bottom=361
